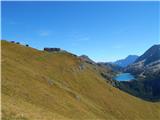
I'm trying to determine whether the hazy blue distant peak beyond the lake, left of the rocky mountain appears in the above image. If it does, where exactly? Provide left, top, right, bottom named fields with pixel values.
left=114, top=55, right=138, bottom=67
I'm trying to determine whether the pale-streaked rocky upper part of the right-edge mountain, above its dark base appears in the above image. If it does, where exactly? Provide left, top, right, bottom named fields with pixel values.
left=125, top=45, right=160, bottom=77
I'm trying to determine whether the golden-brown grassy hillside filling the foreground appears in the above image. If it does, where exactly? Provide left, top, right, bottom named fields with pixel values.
left=1, top=41, right=160, bottom=120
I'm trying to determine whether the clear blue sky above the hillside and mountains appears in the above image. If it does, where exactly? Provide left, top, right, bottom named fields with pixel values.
left=1, top=1, right=160, bottom=61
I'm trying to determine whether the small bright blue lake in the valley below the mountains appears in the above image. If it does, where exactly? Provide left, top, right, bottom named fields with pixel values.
left=114, top=73, right=135, bottom=81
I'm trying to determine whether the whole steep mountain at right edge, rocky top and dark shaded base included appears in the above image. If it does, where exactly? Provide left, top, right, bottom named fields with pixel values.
left=119, top=45, right=160, bottom=101
